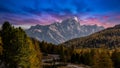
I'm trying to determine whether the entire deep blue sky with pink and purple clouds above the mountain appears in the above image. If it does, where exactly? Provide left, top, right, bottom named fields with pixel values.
left=0, top=0, right=120, bottom=28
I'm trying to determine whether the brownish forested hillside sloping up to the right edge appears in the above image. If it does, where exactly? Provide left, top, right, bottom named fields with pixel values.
left=63, top=25, right=120, bottom=48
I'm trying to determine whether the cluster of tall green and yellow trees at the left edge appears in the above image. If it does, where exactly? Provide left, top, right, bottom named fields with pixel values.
left=0, top=22, right=41, bottom=68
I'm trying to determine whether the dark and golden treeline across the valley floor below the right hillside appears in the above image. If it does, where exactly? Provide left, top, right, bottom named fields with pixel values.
left=40, top=42, right=120, bottom=68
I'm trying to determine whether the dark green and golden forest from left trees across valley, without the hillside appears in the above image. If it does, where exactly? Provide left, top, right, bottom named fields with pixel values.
left=0, top=22, right=120, bottom=68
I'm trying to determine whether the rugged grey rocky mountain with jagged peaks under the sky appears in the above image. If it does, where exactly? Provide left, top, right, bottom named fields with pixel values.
left=26, top=17, right=104, bottom=44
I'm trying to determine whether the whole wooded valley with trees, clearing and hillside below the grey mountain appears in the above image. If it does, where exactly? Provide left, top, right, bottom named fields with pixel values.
left=0, top=22, right=120, bottom=68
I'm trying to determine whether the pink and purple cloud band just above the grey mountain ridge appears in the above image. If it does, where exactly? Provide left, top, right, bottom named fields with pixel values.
left=0, top=13, right=120, bottom=28
